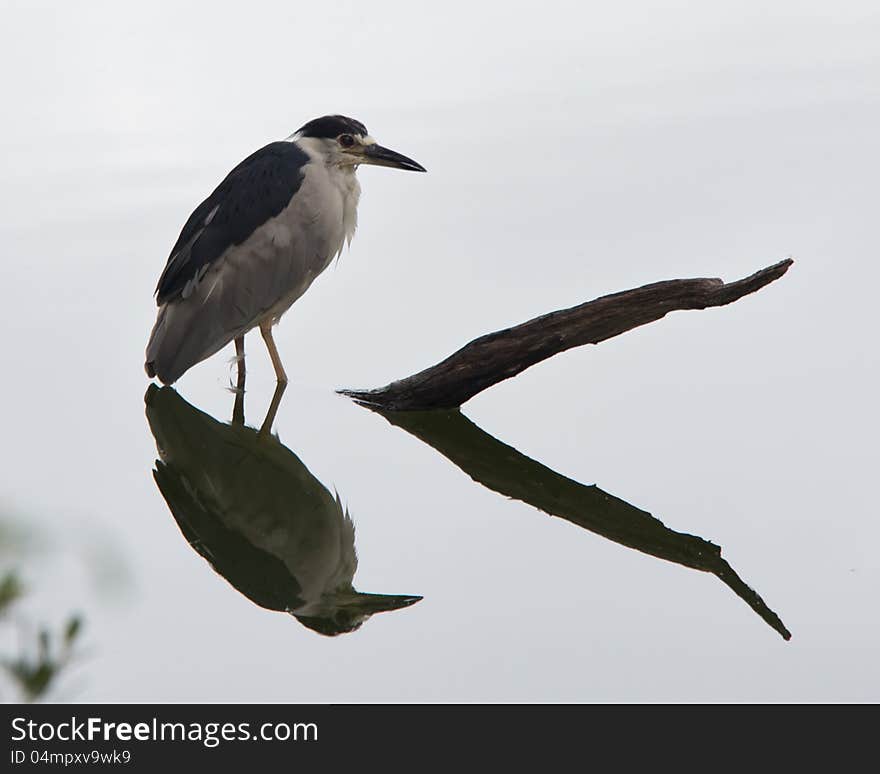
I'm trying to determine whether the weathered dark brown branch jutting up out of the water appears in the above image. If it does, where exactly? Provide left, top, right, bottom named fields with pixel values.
left=341, top=259, right=792, bottom=411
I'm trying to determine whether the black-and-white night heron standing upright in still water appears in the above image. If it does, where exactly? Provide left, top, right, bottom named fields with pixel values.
left=144, top=115, right=427, bottom=385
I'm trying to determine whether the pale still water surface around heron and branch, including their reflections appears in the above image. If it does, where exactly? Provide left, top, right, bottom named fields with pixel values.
left=0, top=4, right=880, bottom=702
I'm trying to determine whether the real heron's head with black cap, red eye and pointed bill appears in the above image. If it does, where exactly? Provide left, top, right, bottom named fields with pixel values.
left=291, top=116, right=427, bottom=172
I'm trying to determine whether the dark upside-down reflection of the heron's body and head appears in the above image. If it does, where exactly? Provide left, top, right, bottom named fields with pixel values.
left=145, top=385, right=421, bottom=635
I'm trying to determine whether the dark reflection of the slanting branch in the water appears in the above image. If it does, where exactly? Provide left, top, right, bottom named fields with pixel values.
left=374, top=409, right=791, bottom=640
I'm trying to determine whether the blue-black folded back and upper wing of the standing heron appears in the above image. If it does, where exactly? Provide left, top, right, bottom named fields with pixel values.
left=156, top=142, right=309, bottom=306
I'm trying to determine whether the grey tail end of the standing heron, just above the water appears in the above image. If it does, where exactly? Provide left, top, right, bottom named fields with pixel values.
left=144, top=301, right=238, bottom=384
